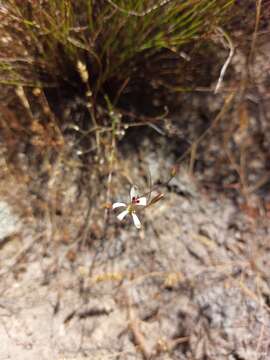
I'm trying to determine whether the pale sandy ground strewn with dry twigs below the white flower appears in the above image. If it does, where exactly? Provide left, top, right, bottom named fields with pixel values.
left=0, top=164, right=270, bottom=360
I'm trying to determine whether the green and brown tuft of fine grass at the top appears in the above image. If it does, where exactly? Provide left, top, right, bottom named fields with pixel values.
left=0, top=0, right=234, bottom=96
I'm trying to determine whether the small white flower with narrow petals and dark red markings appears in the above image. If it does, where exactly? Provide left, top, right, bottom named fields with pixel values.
left=112, top=186, right=147, bottom=229
